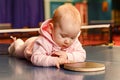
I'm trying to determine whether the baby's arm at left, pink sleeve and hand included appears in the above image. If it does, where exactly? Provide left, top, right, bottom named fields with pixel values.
left=31, top=44, right=66, bottom=68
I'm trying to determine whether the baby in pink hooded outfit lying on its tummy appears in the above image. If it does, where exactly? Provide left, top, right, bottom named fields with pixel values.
left=8, top=3, right=86, bottom=68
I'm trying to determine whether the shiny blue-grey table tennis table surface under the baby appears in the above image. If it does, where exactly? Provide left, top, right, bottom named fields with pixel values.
left=0, top=45, right=120, bottom=80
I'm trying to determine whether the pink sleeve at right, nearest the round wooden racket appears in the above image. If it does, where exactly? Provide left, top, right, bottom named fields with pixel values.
left=67, top=40, right=86, bottom=62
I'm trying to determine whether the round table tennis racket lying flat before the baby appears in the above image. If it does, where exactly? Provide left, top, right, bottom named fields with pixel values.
left=63, top=62, right=105, bottom=72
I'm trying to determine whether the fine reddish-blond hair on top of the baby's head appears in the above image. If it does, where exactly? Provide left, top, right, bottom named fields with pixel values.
left=52, top=3, right=81, bottom=25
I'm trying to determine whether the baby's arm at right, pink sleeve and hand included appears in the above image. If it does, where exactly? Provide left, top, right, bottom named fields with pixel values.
left=54, top=40, right=86, bottom=64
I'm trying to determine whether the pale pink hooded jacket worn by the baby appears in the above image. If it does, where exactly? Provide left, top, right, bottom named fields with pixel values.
left=24, top=19, right=86, bottom=66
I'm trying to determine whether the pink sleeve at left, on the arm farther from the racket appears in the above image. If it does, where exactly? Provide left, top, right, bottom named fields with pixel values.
left=31, top=43, right=58, bottom=66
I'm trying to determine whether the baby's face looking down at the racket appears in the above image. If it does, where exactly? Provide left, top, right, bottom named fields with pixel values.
left=52, top=22, right=80, bottom=49
